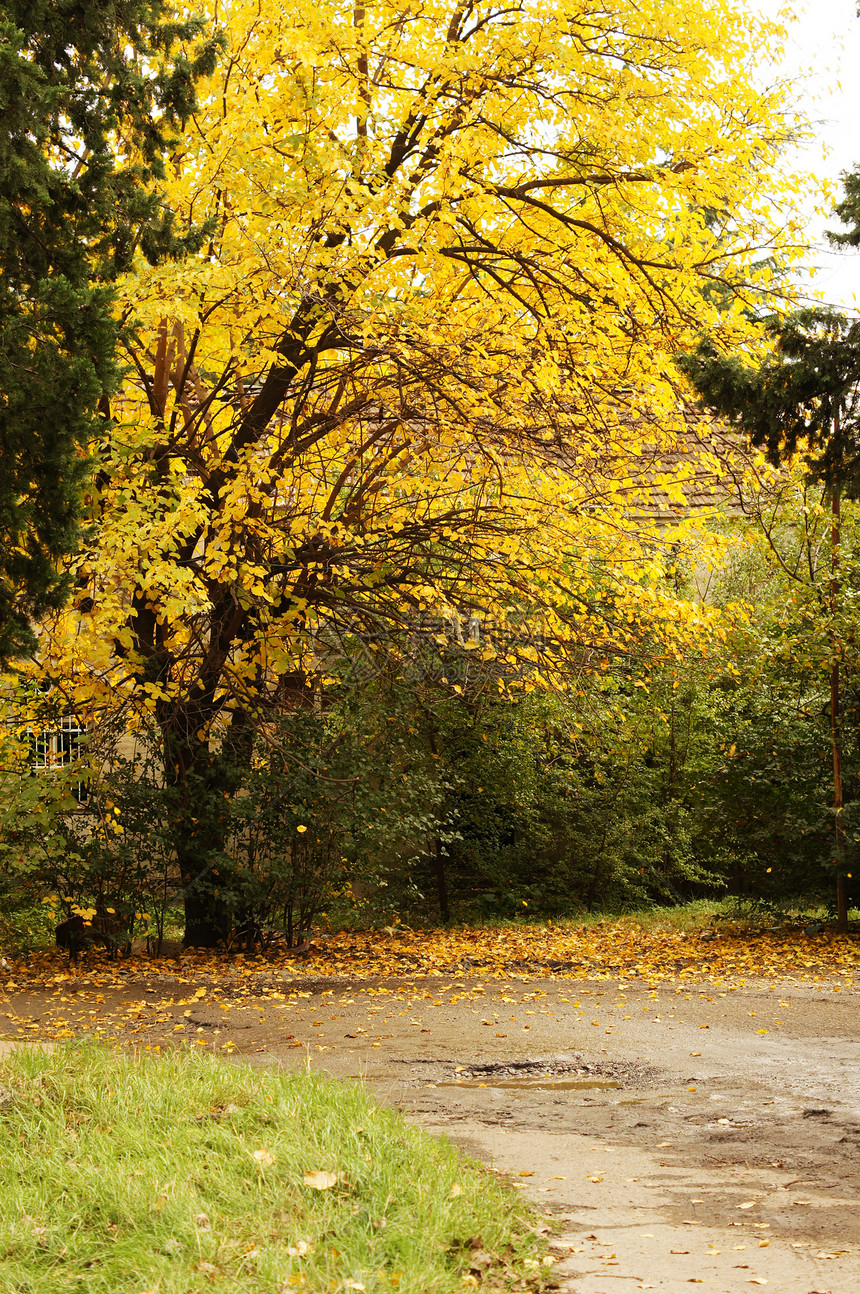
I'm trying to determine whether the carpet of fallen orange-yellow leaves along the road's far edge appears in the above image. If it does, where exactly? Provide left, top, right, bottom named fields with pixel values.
left=8, top=917, right=860, bottom=989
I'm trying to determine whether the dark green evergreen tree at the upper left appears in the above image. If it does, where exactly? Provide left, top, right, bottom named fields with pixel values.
left=0, top=0, right=221, bottom=661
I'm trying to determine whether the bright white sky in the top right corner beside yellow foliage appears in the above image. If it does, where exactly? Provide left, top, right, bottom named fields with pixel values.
left=747, top=0, right=860, bottom=309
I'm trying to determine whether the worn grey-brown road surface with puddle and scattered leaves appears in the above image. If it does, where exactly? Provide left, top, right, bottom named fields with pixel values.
left=0, top=963, right=860, bottom=1294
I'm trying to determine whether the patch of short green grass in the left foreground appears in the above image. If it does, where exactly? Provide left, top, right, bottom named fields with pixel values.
left=0, top=1047, right=546, bottom=1294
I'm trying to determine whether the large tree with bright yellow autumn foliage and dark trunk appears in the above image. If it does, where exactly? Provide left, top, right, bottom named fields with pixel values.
left=28, top=0, right=794, bottom=945
